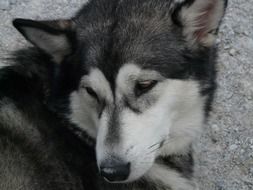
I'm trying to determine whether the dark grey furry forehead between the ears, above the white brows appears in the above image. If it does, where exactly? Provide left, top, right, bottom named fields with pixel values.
left=79, top=0, right=190, bottom=84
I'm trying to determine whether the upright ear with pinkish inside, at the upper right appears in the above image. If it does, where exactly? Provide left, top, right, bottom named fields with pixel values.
left=172, top=0, right=227, bottom=47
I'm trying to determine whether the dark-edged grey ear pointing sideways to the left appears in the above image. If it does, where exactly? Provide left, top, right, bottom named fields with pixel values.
left=13, top=19, right=75, bottom=63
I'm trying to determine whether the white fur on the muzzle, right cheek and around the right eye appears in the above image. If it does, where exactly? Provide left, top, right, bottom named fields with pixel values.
left=97, top=64, right=204, bottom=181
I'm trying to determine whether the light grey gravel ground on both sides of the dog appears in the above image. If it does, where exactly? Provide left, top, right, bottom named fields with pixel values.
left=0, top=0, right=253, bottom=190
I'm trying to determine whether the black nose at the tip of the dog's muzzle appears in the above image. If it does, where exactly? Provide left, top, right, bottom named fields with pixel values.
left=100, top=160, right=130, bottom=182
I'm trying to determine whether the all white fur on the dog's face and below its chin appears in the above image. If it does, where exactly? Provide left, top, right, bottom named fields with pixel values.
left=67, top=64, right=204, bottom=187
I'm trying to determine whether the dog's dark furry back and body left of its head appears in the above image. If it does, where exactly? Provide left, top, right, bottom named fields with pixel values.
left=0, top=50, right=95, bottom=190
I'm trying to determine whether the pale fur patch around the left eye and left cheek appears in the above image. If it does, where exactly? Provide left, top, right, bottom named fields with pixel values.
left=70, top=69, right=113, bottom=138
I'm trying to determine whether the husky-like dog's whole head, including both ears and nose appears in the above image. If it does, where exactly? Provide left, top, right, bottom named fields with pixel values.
left=14, top=0, right=225, bottom=182
